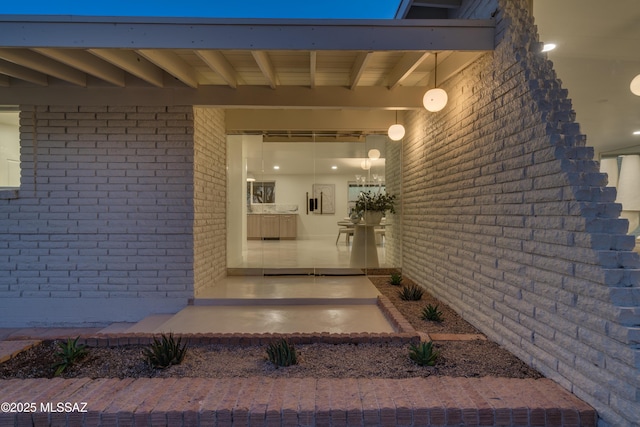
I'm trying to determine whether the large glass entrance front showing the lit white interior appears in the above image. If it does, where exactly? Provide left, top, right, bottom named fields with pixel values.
left=227, top=132, right=401, bottom=275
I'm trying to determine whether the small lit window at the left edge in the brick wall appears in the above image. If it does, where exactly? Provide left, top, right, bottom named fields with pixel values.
left=0, top=107, right=20, bottom=188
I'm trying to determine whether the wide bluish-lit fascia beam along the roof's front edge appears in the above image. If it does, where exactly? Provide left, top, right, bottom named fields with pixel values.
left=0, top=15, right=495, bottom=52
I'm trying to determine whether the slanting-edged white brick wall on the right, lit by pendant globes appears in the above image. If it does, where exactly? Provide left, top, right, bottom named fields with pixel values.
left=402, top=0, right=640, bottom=426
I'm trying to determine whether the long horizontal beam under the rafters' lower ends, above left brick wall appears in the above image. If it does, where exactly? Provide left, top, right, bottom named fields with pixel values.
left=0, top=85, right=428, bottom=109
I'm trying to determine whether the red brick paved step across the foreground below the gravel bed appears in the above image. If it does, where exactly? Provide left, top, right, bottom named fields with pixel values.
left=0, top=377, right=597, bottom=427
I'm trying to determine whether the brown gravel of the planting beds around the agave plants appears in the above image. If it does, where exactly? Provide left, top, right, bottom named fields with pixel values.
left=0, top=277, right=541, bottom=378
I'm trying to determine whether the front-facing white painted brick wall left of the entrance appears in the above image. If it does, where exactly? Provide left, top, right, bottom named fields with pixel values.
left=0, top=106, right=194, bottom=323
